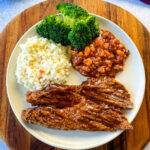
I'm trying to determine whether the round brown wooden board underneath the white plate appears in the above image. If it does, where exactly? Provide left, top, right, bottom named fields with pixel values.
left=0, top=0, right=150, bottom=150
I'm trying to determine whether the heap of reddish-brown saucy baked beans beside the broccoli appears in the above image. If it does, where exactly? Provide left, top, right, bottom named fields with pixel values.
left=71, top=29, right=129, bottom=77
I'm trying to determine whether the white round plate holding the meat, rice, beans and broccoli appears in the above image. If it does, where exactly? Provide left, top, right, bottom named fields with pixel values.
left=6, top=15, right=145, bottom=149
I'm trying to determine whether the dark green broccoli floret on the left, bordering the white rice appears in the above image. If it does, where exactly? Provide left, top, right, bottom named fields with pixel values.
left=36, top=15, right=71, bottom=45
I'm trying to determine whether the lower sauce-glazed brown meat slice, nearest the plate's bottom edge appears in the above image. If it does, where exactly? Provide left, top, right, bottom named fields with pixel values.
left=22, top=98, right=132, bottom=131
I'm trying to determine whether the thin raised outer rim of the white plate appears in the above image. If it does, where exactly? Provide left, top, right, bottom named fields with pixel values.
left=6, top=13, right=146, bottom=149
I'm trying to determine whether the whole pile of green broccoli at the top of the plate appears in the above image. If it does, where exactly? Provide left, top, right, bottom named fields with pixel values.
left=36, top=3, right=100, bottom=50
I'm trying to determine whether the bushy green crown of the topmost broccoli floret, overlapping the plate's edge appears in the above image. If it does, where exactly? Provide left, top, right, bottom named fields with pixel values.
left=56, top=3, right=89, bottom=19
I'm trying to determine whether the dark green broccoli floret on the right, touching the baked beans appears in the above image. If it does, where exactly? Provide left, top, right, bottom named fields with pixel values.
left=68, top=16, right=99, bottom=50
